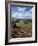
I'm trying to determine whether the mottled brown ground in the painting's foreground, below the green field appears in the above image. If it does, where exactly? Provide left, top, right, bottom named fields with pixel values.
left=11, top=28, right=32, bottom=38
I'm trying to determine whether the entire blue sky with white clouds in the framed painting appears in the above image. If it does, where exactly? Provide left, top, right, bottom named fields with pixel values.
left=11, top=6, right=32, bottom=19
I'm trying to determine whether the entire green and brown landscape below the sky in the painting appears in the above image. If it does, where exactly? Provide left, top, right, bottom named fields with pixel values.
left=11, top=19, right=32, bottom=38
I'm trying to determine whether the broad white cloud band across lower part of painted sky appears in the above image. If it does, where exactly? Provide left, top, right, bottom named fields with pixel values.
left=12, top=9, right=32, bottom=19
